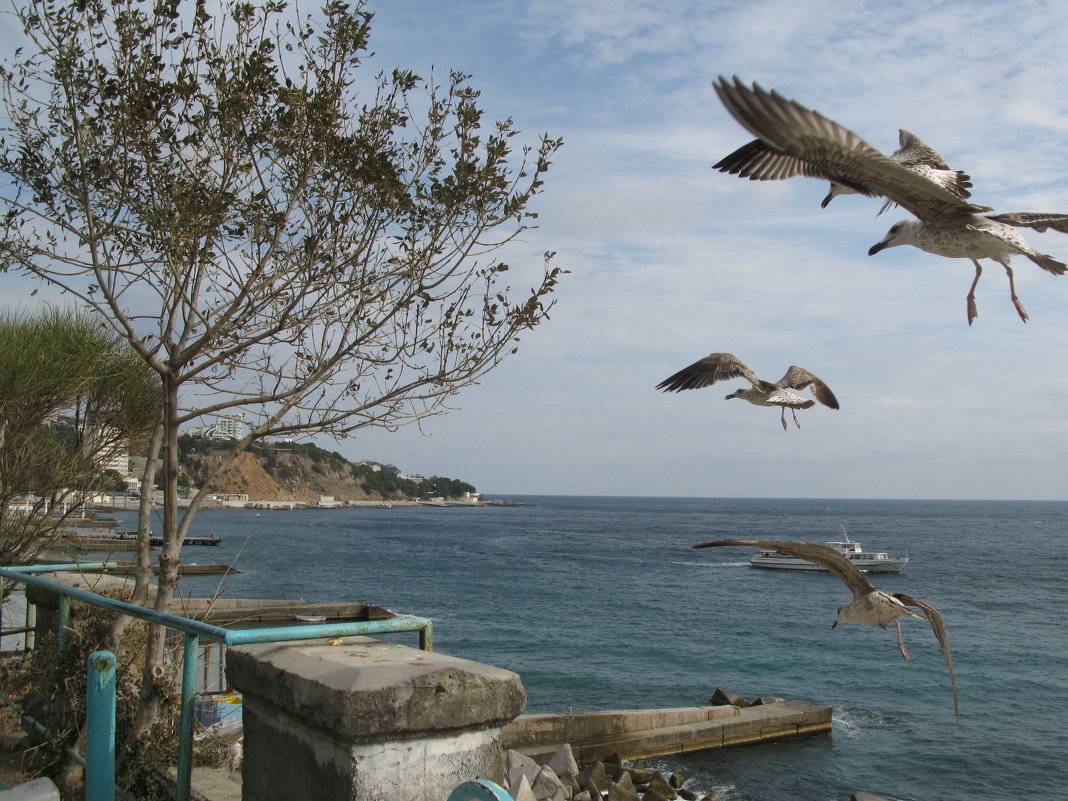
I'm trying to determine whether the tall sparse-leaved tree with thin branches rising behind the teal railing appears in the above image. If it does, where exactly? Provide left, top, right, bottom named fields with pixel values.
left=0, top=0, right=561, bottom=747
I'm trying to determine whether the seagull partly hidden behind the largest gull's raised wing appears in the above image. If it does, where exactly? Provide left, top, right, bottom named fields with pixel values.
left=712, top=128, right=972, bottom=215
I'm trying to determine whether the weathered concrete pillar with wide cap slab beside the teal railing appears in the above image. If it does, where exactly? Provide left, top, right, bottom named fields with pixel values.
left=226, top=637, right=527, bottom=801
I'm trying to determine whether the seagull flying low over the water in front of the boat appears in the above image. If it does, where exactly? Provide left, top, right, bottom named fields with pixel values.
left=693, top=539, right=960, bottom=725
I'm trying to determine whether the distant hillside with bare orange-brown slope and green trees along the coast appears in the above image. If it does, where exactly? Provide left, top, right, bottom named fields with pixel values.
left=179, top=436, right=474, bottom=501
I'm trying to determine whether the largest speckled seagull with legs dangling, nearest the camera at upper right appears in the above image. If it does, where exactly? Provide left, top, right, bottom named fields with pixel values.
left=713, top=77, right=1068, bottom=325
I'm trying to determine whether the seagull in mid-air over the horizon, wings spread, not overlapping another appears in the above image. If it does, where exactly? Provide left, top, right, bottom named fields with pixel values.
left=657, top=354, right=838, bottom=430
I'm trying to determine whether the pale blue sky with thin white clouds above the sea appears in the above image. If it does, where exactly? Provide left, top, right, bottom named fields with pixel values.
left=10, top=0, right=1068, bottom=500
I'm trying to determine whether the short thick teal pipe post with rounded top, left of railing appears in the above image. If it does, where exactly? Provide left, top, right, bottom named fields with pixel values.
left=85, top=650, right=115, bottom=801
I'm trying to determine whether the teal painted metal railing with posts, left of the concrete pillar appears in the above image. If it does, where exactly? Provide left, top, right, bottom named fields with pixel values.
left=0, top=562, right=433, bottom=801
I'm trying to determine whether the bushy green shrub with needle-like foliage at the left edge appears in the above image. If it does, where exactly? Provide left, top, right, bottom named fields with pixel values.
left=0, top=308, right=159, bottom=565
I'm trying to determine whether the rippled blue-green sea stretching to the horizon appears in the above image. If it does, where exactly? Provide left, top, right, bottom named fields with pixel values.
left=104, top=496, right=1068, bottom=801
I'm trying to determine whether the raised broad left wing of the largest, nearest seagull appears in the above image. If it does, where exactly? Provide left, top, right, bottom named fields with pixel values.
left=713, top=77, right=990, bottom=223
